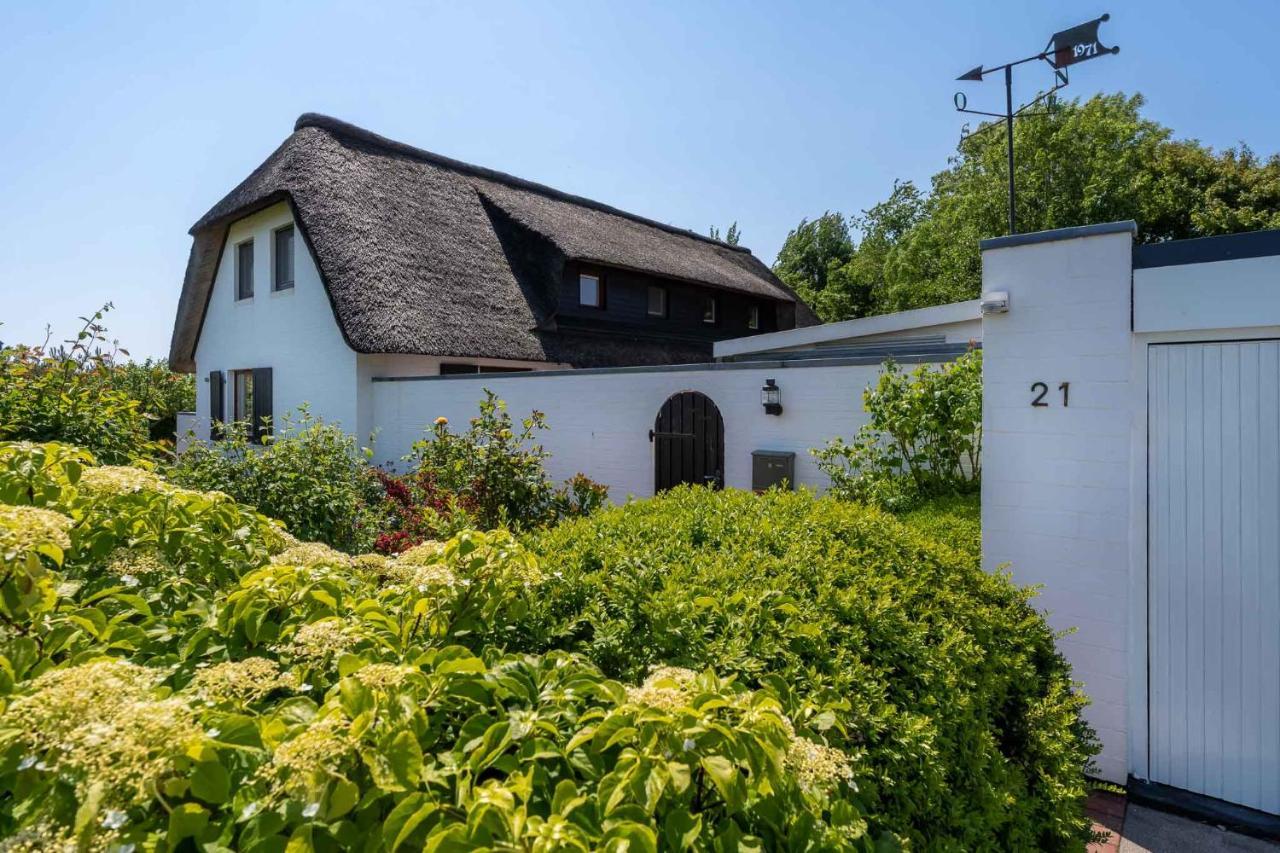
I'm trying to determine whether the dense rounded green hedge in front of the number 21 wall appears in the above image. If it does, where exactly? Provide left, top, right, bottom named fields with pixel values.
left=522, top=488, right=1096, bottom=849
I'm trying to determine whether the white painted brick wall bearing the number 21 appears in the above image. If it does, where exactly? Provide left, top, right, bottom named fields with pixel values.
left=982, top=227, right=1133, bottom=781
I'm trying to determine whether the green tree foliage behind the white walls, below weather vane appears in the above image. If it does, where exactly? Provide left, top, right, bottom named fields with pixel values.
left=774, top=95, right=1280, bottom=320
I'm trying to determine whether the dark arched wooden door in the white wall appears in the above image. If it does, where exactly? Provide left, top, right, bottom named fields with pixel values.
left=649, top=391, right=724, bottom=492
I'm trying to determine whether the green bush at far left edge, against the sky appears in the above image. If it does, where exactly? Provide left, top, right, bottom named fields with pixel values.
left=0, top=304, right=155, bottom=464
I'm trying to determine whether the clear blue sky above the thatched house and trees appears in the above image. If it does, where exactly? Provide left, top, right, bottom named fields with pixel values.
left=0, top=0, right=1280, bottom=356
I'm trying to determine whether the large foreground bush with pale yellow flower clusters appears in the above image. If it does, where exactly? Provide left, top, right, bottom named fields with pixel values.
left=0, top=444, right=870, bottom=852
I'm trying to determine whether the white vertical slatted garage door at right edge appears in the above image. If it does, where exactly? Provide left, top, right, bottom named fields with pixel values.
left=1147, top=341, right=1280, bottom=813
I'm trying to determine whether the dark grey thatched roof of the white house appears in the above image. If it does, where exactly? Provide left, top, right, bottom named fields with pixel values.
left=169, top=113, right=815, bottom=370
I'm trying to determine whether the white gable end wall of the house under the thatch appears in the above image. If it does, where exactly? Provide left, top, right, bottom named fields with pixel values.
left=186, top=202, right=357, bottom=437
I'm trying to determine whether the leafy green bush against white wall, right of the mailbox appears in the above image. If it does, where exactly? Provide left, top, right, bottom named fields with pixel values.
left=812, top=350, right=982, bottom=510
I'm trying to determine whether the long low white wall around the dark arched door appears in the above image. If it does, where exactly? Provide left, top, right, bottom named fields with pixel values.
left=372, top=364, right=901, bottom=491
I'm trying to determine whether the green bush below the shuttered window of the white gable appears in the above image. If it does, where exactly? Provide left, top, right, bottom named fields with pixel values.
left=169, top=407, right=381, bottom=552
